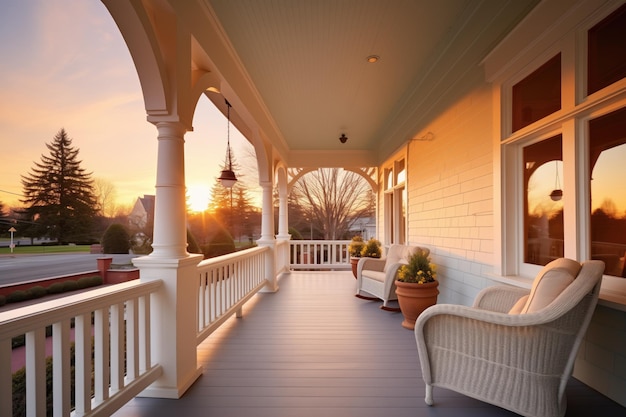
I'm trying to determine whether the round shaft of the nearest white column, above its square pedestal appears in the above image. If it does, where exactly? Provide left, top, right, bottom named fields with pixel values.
left=150, top=122, right=187, bottom=258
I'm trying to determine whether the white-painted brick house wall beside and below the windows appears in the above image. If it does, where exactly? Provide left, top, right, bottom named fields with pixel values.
left=379, top=53, right=626, bottom=406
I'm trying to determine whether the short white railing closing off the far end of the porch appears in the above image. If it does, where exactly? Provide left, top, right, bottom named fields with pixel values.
left=289, top=240, right=351, bottom=270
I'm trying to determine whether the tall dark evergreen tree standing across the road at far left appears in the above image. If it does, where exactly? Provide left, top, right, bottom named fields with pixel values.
left=21, top=129, right=98, bottom=244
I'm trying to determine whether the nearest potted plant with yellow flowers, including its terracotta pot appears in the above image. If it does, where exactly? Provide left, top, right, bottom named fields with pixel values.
left=395, top=250, right=439, bottom=330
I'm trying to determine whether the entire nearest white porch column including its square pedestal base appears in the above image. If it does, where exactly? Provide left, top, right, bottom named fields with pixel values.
left=133, top=122, right=202, bottom=398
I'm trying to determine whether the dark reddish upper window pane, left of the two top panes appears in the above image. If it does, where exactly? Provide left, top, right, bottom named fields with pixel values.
left=512, top=54, right=561, bottom=132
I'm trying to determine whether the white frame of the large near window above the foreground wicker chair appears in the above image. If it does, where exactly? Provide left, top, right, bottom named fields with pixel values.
left=493, top=0, right=626, bottom=309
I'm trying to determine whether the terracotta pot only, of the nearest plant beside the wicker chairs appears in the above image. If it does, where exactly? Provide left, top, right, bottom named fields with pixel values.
left=396, top=281, right=439, bottom=330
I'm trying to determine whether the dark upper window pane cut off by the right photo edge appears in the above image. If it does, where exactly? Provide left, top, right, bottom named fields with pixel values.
left=587, top=5, right=626, bottom=94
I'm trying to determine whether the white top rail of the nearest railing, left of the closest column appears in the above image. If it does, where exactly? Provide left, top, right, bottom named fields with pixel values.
left=0, top=280, right=163, bottom=340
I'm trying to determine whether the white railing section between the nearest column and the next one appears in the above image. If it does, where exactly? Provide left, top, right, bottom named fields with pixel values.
left=197, top=247, right=270, bottom=344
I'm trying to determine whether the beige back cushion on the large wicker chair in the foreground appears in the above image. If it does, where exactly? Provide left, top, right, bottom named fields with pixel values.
left=509, top=258, right=581, bottom=314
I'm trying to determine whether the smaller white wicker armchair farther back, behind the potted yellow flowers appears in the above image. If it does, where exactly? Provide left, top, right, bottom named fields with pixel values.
left=356, top=244, right=430, bottom=311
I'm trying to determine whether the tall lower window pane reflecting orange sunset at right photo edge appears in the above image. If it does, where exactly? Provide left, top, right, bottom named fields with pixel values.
left=589, top=109, right=626, bottom=278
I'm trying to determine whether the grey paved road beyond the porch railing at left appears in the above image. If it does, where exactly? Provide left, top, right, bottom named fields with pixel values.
left=0, top=253, right=137, bottom=286
